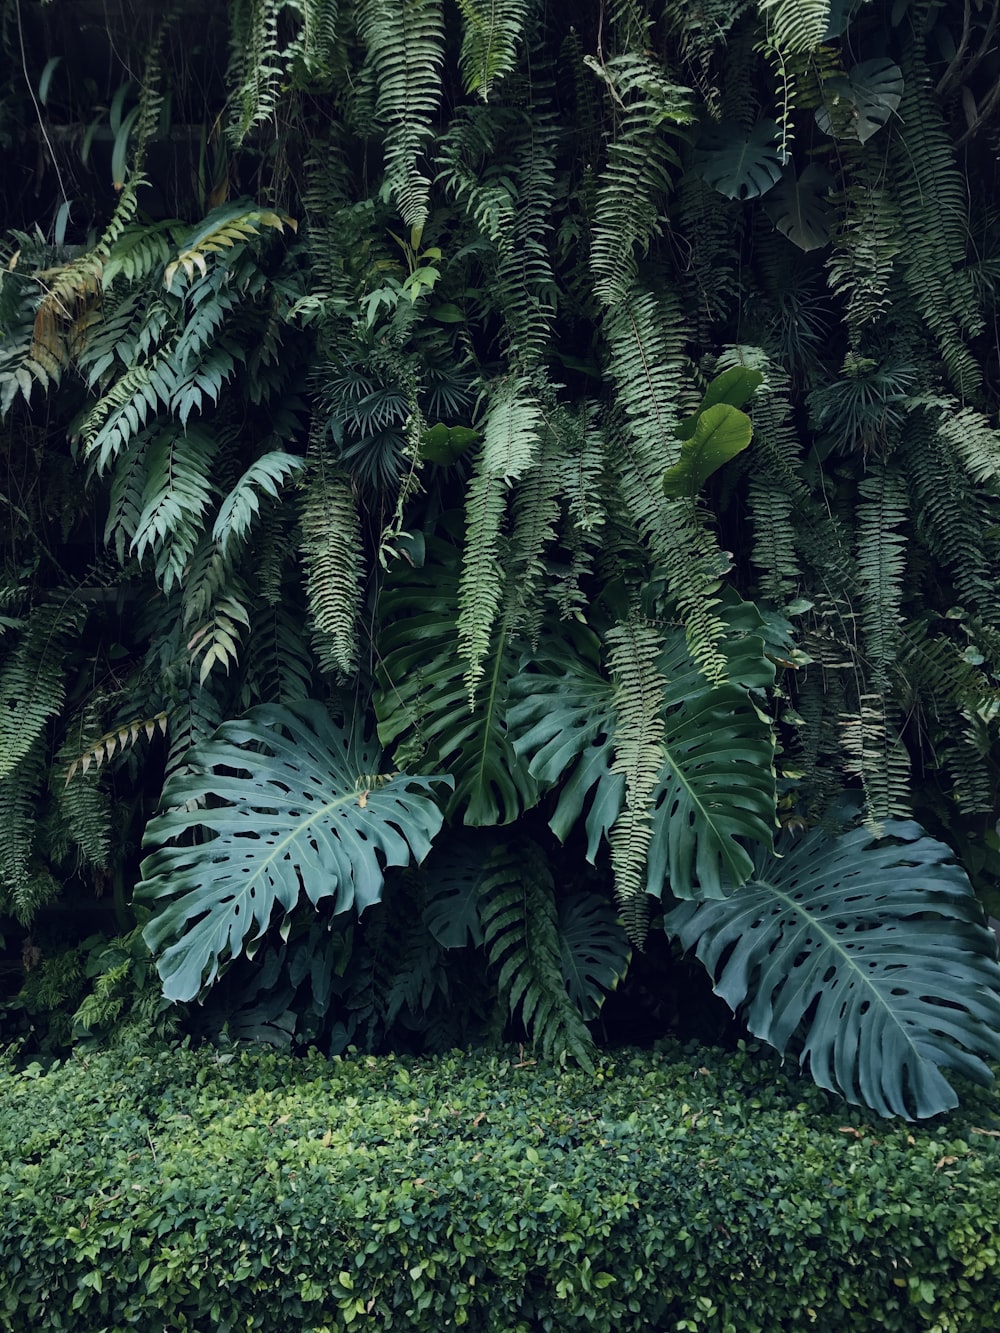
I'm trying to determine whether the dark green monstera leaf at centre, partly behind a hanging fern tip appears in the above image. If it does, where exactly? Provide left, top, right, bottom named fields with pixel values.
left=375, top=539, right=537, bottom=826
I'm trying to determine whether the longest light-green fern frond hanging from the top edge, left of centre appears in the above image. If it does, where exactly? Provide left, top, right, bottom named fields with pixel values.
left=357, top=0, right=444, bottom=240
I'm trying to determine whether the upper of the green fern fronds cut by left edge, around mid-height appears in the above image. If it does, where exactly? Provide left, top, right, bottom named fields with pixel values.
left=0, top=593, right=87, bottom=780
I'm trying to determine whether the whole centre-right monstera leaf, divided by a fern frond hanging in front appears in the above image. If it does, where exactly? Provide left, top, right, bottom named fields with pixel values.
left=508, top=604, right=775, bottom=897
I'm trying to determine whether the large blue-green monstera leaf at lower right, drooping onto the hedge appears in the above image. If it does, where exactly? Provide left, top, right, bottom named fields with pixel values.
left=664, top=821, right=1000, bottom=1117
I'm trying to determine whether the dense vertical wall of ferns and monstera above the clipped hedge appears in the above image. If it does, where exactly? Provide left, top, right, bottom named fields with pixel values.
left=0, top=0, right=1000, bottom=1117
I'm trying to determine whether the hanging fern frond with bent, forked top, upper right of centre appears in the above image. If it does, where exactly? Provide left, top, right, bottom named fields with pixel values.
left=587, top=52, right=695, bottom=305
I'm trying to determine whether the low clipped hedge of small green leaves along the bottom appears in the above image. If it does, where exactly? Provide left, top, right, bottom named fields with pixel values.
left=0, top=1049, right=1000, bottom=1333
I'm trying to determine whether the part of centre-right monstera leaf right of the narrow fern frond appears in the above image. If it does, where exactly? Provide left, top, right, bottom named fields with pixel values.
left=647, top=632, right=776, bottom=898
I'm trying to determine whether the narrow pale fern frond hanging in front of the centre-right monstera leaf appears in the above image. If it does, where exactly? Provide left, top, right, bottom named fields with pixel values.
left=607, top=617, right=667, bottom=944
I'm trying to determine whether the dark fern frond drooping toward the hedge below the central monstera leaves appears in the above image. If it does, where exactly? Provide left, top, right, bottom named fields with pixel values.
left=480, top=844, right=593, bottom=1069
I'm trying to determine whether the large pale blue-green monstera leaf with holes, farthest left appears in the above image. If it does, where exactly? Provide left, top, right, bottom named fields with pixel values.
left=136, top=701, right=451, bottom=1000
